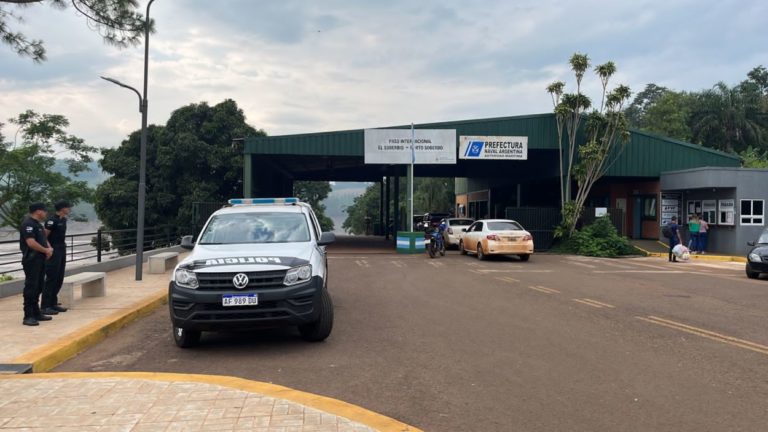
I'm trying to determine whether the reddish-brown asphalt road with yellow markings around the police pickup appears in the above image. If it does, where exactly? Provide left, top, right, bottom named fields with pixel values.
left=58, top=248, right=768, bottom=432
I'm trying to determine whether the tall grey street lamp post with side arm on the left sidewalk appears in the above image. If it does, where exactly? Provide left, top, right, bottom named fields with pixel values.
left=101, top=0, right=155, bottom=281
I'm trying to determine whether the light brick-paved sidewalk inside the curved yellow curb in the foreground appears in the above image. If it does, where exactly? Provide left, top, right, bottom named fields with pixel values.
left=0, top=374, right=382, bottom=432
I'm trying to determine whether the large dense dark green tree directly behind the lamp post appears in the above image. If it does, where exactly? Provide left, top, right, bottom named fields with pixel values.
left=95, top=99, right=266, bottom=234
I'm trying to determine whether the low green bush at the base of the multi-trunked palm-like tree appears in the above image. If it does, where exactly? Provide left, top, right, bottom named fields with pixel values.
left=557, top=217, right=638, bottom=258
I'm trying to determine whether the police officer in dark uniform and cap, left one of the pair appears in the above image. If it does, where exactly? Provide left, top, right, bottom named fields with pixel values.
left=19, top=203, right=53, bottom=326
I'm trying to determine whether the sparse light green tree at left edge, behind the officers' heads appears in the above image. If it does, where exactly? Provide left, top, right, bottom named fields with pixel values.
left=0, top=111, right=96, bottom=228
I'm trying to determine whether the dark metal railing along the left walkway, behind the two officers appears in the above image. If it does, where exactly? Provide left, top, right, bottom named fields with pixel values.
left=0, top=225, right=181, bottom=275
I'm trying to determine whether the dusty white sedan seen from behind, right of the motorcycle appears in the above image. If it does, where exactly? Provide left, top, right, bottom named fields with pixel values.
left=459, top=219, right=533, bottom=261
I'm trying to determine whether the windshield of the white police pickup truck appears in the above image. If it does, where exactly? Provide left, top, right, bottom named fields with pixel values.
left=200, top=212, right=310, bottom=244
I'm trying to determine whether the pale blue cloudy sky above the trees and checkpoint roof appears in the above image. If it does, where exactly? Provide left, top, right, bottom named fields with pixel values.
left=0, top=0, right=768, bottom=152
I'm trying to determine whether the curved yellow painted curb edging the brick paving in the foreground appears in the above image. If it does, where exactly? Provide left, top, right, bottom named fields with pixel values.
left=0, top=372, right=422, bottom=432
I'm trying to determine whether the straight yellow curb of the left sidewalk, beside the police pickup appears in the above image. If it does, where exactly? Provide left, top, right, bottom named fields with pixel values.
left=12, top=291, right=168, bottom=372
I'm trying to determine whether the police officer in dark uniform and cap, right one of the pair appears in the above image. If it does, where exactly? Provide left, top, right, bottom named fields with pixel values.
left=40, top=201, right=72, bottom=315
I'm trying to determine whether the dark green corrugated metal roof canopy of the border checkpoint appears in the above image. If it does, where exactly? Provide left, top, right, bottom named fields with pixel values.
left=244, top=114, right=741, bottom=181
